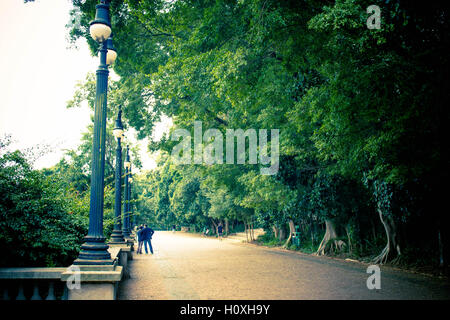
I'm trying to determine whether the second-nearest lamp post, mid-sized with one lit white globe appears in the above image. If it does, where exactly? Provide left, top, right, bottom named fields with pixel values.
left=111, top=106, right=125, bottom=243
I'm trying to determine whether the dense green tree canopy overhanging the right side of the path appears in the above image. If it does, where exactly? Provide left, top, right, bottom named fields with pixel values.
left=66, top=0, right=450, bottom=264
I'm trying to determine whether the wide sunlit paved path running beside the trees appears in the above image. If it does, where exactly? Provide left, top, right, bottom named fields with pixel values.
left=119, top=231, right=450, bottom=300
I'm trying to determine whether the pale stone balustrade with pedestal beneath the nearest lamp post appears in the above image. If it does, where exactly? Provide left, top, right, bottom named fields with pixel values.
left=0, top=244, right=132, bottom=300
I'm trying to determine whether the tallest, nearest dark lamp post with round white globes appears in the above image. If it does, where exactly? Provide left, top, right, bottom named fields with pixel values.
left=74, top=0, right=115, bottom=265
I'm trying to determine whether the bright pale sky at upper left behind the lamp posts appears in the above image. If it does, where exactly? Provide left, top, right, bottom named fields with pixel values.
left=0, top=0, right=167, bottom=170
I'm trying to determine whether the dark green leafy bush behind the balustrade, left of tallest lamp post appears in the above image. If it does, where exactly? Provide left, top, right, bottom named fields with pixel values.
left=0, top=144, right=88, bottom=267
